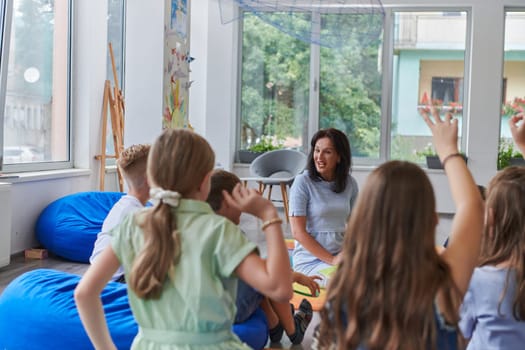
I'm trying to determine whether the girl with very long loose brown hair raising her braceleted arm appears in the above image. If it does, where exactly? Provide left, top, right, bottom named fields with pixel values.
left=314, top=111, right=483, bottom=350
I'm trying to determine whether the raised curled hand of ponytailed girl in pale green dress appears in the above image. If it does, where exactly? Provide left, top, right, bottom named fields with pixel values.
left=222, top=183, right=278, bottom=221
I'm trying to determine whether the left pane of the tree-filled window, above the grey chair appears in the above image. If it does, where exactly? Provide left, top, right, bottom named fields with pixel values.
left=240, top=13, right=310, bottom=149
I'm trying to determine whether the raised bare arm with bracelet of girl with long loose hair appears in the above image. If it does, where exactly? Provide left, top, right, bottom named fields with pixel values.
left=422, top=110, right=483, bottom=296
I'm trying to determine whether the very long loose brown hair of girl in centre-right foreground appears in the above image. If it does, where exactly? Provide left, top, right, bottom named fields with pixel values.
left=319, top=161, right=460, bottom=350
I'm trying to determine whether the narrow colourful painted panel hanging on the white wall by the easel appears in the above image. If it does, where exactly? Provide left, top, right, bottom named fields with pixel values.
left=162, top=0, right=192, bottom=129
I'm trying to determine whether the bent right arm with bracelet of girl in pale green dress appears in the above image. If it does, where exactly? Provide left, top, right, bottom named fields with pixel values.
left=223, top=184, right=293, bottom=302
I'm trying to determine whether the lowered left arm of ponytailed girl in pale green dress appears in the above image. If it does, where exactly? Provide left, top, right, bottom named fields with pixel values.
left=75, top=246, right=120, bottom=349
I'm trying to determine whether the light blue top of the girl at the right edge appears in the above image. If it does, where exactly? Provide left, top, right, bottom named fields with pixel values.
left=459, top=266, right=525, bottom=350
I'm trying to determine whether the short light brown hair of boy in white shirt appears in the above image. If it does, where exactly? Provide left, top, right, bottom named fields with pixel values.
left=117, top=144, right=151, bottom=188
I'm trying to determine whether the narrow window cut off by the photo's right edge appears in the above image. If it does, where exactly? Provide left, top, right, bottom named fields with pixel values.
left=498, top=11, right=525, bottom=168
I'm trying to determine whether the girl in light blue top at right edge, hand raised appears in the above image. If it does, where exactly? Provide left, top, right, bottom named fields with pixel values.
left=460, top=114, right=525, bottom=349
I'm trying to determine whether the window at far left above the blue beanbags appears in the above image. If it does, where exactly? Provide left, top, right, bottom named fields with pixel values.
left=2, top=0, right=71, bottom=171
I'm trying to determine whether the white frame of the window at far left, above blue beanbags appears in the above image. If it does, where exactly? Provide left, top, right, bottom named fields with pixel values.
left=0, top=0, right=75, bottom=173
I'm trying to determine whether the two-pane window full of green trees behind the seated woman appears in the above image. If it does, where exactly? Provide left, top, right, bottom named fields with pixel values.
left=239, top=8, right=382, bottom=158
